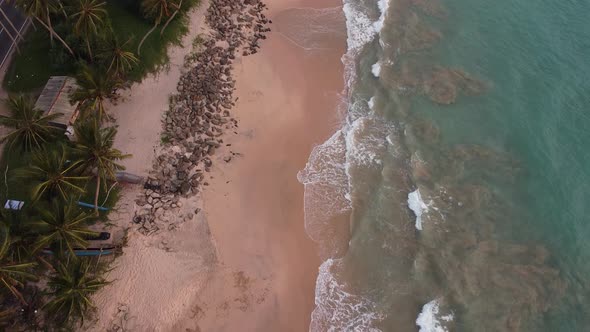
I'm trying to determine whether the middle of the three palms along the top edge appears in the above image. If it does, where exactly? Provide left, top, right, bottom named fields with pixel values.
left=70, top=0, right=107, bottom=59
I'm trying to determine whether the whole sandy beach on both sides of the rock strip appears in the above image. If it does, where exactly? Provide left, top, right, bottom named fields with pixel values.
left=87, top=0, right=345, bottom=331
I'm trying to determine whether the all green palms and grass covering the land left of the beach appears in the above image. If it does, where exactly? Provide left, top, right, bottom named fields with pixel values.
left=0, top=0, right=198, bottom=330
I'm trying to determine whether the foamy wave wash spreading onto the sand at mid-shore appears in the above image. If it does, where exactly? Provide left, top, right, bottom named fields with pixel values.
left=297, top=96, right=395, bottom=246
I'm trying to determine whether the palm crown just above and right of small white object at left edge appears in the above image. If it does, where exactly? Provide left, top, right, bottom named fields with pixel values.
left=14, top=146, right=88, bottom=201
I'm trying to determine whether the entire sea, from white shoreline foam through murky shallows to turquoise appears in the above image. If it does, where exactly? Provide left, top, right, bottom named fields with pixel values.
left=298, top=0, right=590, bottom=332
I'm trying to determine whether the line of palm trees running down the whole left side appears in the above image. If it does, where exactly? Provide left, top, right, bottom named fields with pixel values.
left=0, top=0, right=195, bottom=330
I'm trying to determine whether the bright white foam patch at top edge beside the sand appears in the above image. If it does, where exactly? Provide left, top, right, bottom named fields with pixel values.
left=342, top=0, right=375, bottom=53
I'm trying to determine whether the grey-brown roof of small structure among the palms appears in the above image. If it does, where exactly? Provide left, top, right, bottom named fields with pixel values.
left=35, top=76, right=78, bottom=126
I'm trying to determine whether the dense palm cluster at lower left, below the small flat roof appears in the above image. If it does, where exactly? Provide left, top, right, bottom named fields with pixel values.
left=0, top=104, right=126, bottom=329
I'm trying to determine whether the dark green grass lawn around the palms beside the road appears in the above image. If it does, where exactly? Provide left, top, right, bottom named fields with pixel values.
left=3, top=0, right=199, bottom=93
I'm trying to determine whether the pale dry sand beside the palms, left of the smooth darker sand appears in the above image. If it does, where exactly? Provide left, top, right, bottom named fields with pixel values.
left=86, top=1, right=215, bottom=331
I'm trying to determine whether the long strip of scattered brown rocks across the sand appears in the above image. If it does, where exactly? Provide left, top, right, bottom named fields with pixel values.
left=133, top=0, right=272, bottom=235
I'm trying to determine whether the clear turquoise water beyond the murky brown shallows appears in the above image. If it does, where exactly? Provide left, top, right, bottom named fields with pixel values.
left=446, top=1, right=590, bottom=331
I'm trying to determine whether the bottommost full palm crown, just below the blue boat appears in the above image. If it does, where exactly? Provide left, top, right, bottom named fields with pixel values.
left=45, top=259, right=108, bottom=324
